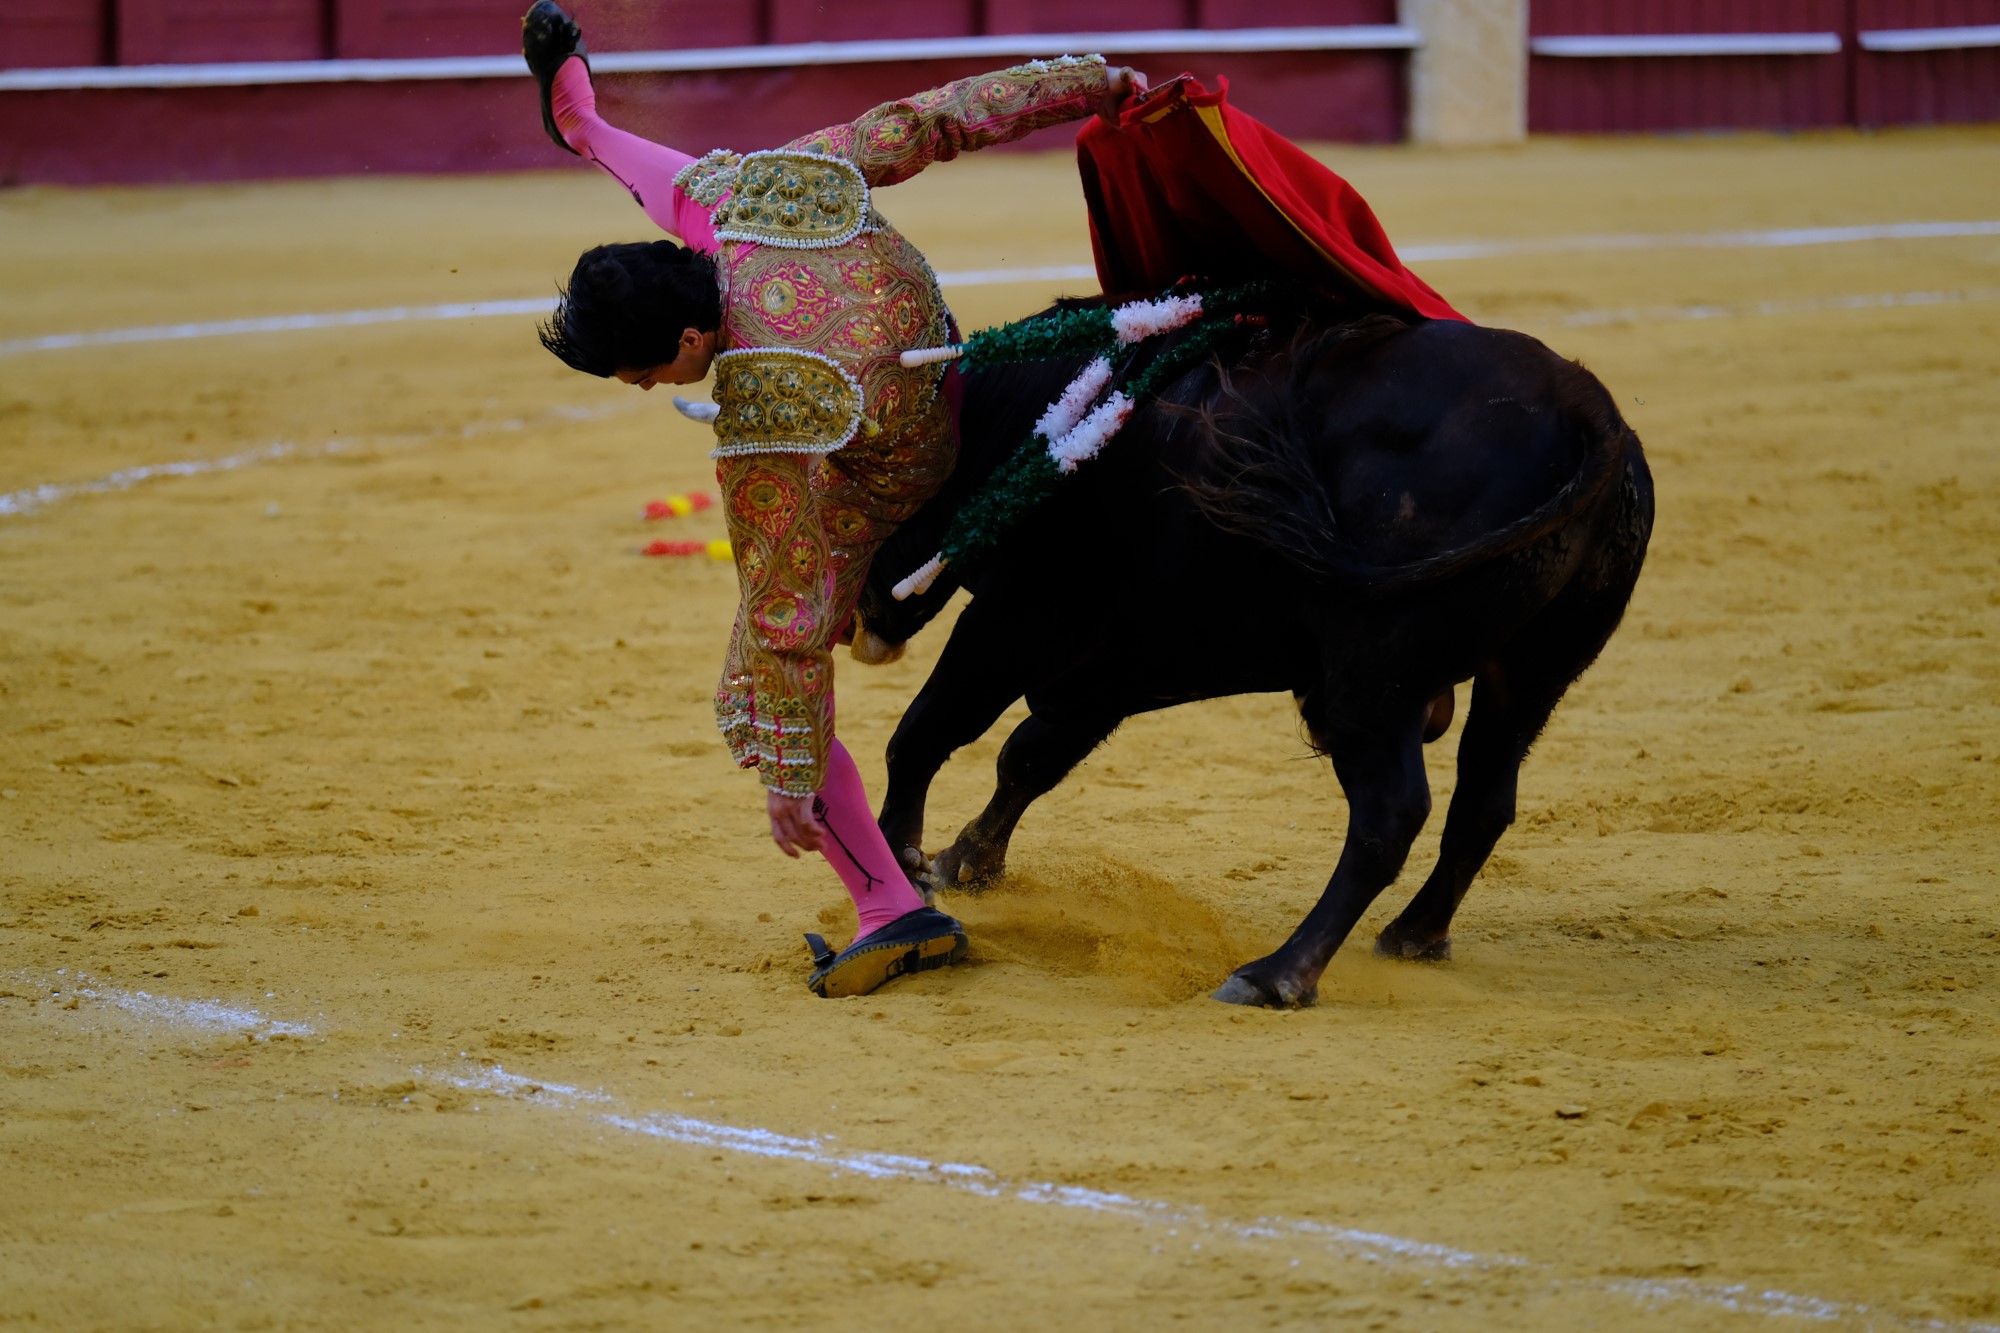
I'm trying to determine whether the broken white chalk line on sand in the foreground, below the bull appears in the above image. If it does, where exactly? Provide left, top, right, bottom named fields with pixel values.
left=18, top=969, right=2000, bottom=1333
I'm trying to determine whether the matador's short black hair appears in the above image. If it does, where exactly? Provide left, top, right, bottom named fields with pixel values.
left=538, top=240, right=722, bottom=378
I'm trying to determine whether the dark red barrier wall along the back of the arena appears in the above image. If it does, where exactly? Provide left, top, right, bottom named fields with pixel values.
left=0, top=0, right=2000, bottom=184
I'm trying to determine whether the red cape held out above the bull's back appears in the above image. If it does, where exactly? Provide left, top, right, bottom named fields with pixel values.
left=1076, top=74, right=1466, bottom=320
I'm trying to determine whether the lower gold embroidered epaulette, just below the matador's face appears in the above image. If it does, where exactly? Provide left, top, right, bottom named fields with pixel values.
left=710, top=346, right=862, bottom=458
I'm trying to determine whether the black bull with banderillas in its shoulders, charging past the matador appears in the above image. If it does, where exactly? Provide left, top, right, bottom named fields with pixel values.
left=862, top=306, right=1652, bottom=1005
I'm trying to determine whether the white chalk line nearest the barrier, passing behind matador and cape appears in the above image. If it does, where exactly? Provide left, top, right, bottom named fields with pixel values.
left=0, top=220, right=2000, bottom=356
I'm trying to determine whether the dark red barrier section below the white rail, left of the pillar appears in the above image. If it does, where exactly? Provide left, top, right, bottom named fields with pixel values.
left=0, top=52, right=1404, bottom=184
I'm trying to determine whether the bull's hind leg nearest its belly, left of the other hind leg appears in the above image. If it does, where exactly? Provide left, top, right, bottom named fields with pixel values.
left=1216, top=699, right=1430, bottom=1007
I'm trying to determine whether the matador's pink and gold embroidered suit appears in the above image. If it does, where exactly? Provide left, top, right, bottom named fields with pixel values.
left=600, top=56, right=1108, bottom=797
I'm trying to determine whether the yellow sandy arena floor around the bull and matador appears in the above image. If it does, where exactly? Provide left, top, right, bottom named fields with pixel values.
left=0, top=122, right=2000, bottom=1329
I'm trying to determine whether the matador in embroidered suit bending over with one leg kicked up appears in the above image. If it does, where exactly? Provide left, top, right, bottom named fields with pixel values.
left=522, top=0, right=1144, bottom=997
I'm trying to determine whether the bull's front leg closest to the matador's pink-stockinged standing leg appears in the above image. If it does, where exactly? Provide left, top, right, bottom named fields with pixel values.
left=878, top=598, right=1028, bottom=879
